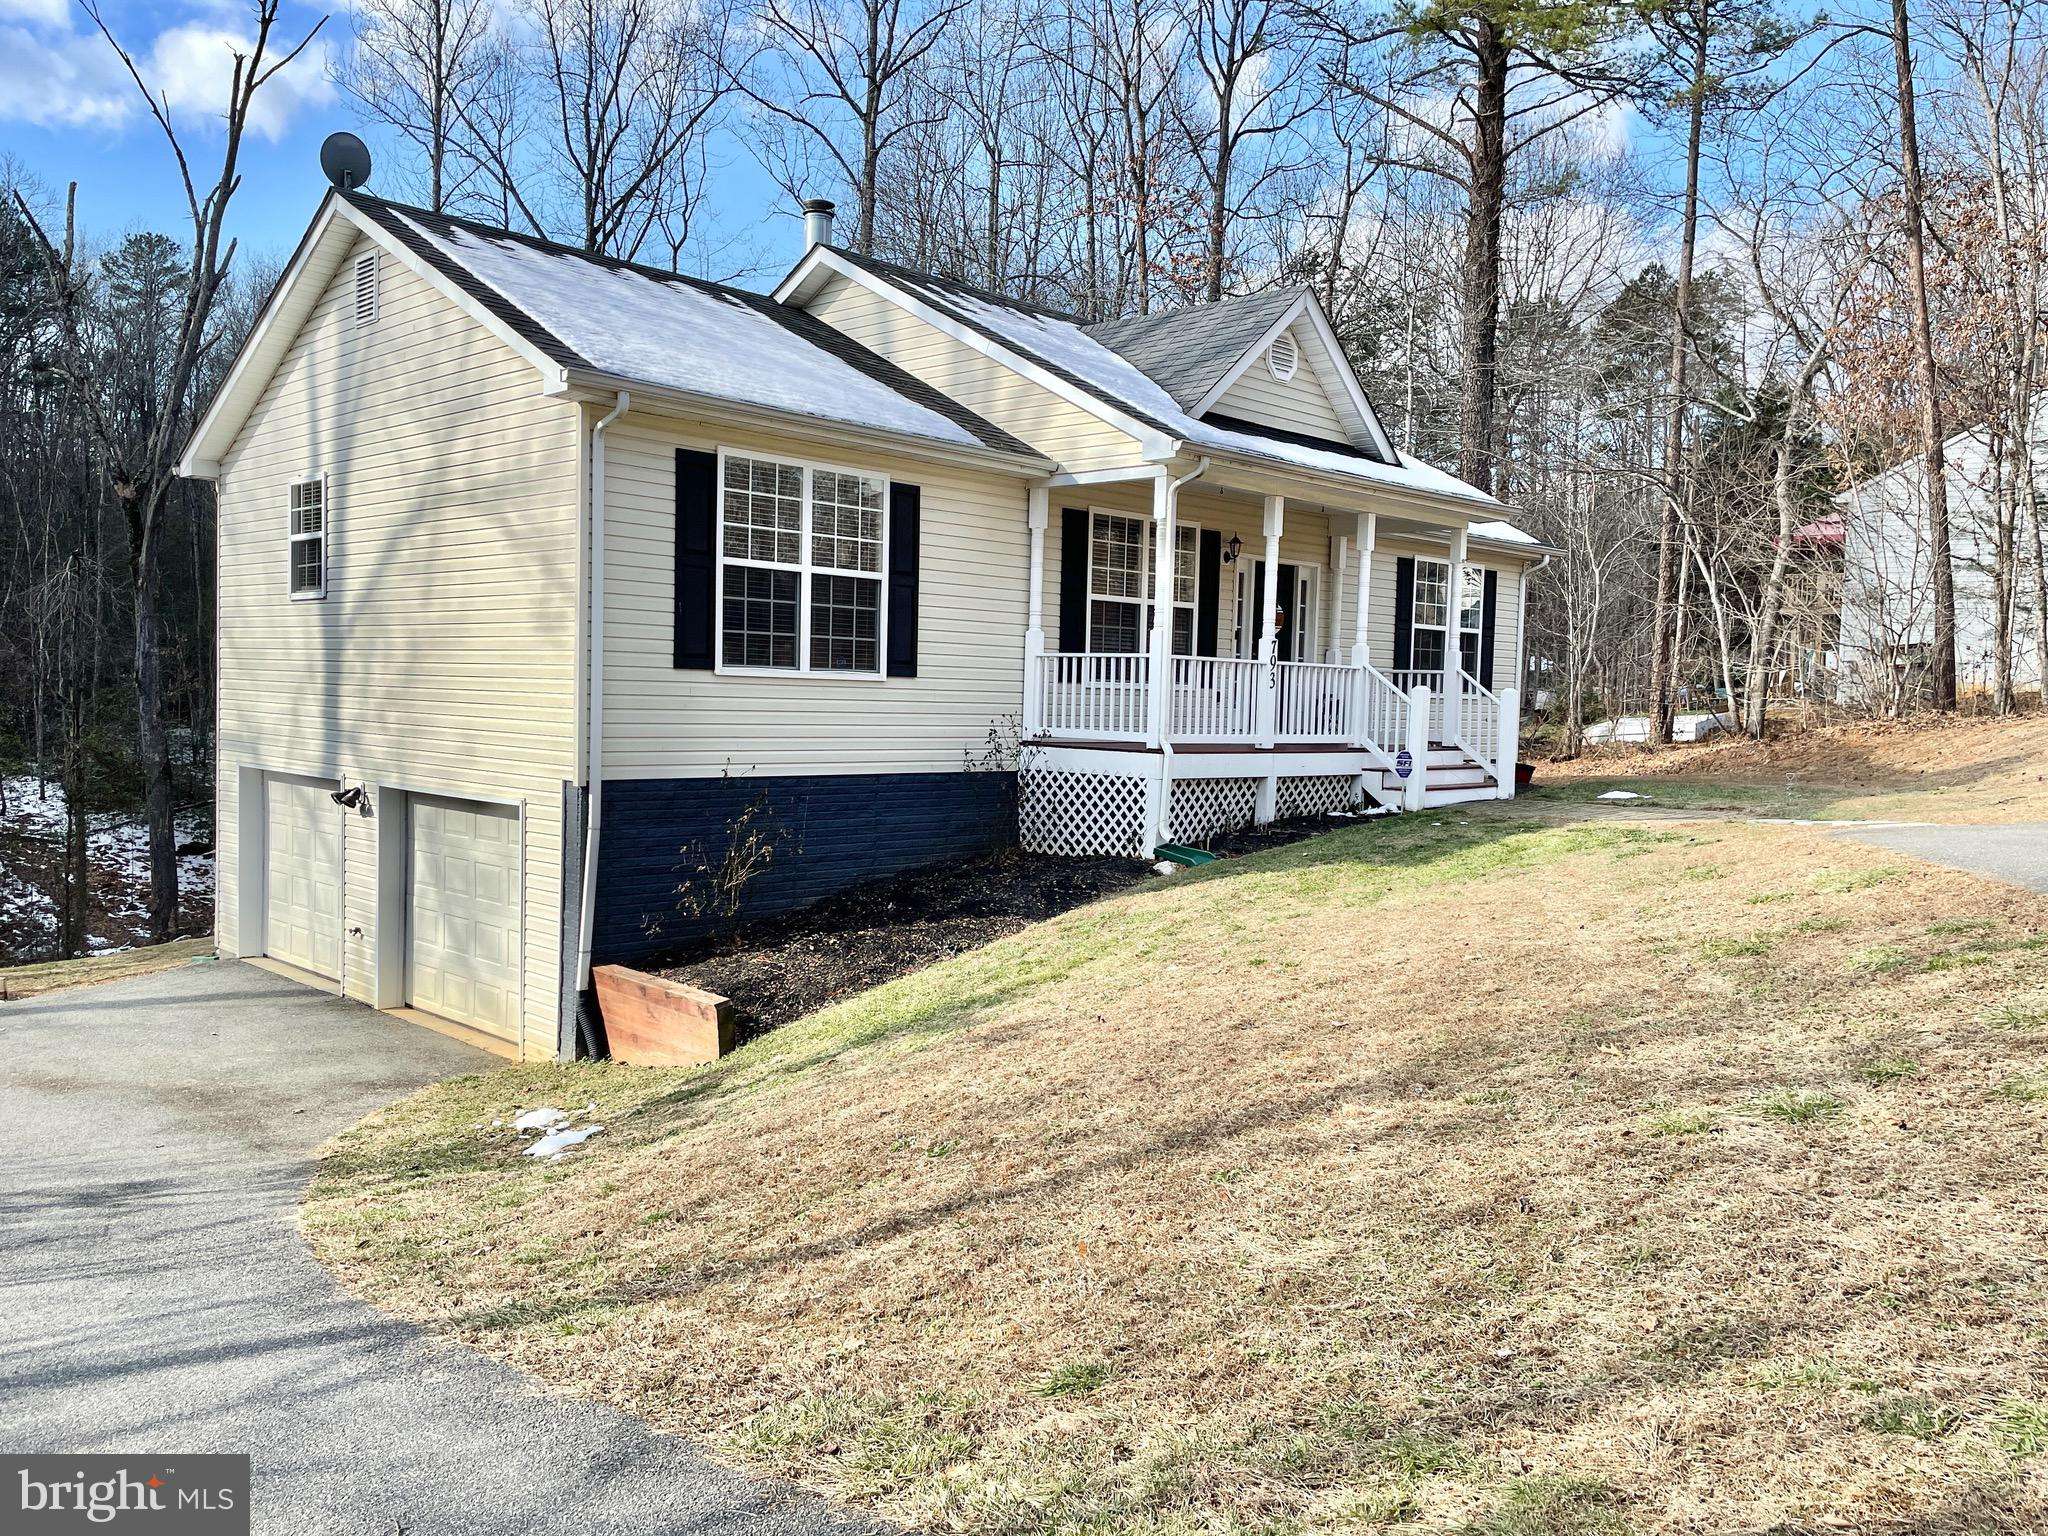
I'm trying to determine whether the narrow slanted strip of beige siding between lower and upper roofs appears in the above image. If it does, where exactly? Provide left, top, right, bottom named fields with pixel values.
left=807, top=274, right=1139, bottom=471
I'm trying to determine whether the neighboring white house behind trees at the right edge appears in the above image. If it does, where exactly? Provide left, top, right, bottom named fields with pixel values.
left=1837, top=422, right=2048, bottom=707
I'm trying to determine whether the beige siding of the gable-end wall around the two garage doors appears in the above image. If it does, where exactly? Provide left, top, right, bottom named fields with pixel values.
left=215, top=234, right=578, bottom=1057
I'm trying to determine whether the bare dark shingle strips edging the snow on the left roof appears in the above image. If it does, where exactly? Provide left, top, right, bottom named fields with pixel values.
left=338, top=193, right=1040, bottom=459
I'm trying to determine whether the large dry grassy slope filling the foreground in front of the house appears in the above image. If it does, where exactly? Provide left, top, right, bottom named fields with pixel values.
left=305, top=807, right=2048, bottom=1536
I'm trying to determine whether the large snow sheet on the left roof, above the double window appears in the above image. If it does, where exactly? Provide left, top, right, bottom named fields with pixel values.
left=393, top=209, right=981, bottom=446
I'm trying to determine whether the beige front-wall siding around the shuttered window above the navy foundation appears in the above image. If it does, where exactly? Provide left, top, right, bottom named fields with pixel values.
left=604, top=412, right=1030, bottom=778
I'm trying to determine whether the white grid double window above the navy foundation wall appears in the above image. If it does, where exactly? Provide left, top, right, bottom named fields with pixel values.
left=719, top=453, right=889, bottom=678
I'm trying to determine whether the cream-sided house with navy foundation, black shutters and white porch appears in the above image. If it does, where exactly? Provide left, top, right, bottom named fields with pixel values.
left=180, top=193, right=1546, bottom=1057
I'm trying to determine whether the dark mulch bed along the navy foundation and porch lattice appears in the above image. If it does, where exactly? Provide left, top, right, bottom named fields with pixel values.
left=659, top=817, right=1352, bottom=1038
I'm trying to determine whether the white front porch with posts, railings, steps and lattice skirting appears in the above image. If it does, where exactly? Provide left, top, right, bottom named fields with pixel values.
left=1020, top=456, right=1520, bottom=856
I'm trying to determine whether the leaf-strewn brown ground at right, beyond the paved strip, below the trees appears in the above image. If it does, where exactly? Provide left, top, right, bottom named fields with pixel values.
left=1538, top=713, right=2048, bottom=821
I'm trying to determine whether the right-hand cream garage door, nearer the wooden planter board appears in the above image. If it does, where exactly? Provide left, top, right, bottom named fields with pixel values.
left=408, top=795, right=518, bottom=1038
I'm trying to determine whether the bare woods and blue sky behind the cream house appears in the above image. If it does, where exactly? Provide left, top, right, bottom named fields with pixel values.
left=0, top=0, right=2048, bottom=952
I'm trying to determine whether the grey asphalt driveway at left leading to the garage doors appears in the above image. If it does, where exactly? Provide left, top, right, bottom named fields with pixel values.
left=0, top=963, right=880, bottom=1536
